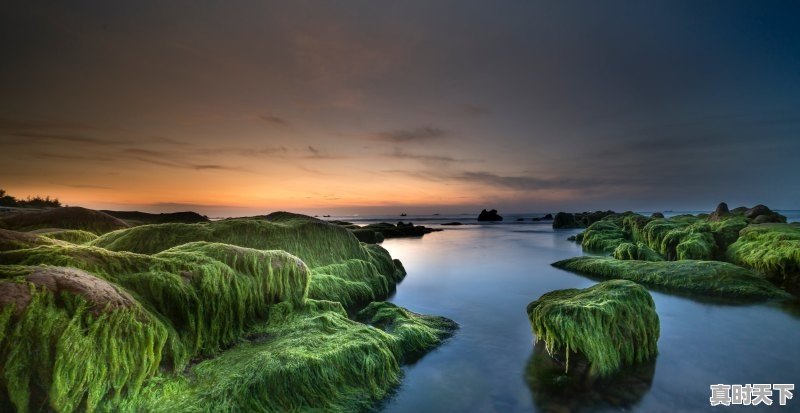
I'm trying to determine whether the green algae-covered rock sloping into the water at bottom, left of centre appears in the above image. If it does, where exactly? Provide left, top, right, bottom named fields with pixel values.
left=129, top=300, right=460, bottom=413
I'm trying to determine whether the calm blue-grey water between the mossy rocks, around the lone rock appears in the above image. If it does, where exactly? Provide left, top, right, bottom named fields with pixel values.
left=382, top=223, right=800, bottom=412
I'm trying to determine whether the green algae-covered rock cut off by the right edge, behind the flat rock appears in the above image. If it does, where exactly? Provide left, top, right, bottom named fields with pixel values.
left=728, top=223, right=800, bottom=290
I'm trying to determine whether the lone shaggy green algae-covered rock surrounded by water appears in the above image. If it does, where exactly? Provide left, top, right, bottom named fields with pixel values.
left=527, top=280, right=659, bottom=376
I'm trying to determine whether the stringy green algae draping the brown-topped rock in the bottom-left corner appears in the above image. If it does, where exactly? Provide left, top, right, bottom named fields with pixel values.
left=0, top=266, right=167, bottom=412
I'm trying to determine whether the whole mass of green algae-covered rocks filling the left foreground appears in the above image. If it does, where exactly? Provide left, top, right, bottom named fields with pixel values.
left=0, top=213, right=455, bottom=412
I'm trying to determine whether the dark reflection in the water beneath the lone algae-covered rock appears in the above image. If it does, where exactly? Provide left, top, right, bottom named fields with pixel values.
left=525, top=341, right=656, bottom=413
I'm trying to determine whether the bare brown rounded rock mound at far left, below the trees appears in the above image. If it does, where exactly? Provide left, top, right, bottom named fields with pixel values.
left=0, top=207, right=128, bottom=235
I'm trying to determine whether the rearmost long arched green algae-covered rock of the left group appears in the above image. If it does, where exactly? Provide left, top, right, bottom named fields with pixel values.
left=91, top=212, right=405, bottom=308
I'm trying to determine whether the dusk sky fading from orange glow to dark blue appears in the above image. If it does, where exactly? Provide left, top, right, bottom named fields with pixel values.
left=0, top=0, right=800, bottom=215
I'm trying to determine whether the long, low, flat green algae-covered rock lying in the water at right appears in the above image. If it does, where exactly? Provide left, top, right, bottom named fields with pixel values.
left=553, top=257, right=791, bottom=300
